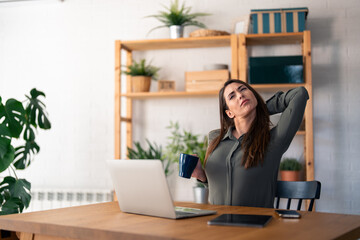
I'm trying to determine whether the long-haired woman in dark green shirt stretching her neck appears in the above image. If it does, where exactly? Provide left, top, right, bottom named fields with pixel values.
left=192, top=80, right=309, bottom=208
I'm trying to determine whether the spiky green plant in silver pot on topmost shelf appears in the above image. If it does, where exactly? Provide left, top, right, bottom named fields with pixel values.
left=148, top=0, right=210, bottom=38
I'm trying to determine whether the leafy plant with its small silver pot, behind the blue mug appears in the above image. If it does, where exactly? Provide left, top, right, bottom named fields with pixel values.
left=165, top=122, right=209, bottom=203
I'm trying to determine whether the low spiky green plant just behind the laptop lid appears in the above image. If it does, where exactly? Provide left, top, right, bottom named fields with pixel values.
left=127, top=139, right=171, bottom=176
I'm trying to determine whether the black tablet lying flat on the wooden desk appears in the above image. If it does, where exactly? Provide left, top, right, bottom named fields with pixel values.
left=208, top=214, right=272, bottom=227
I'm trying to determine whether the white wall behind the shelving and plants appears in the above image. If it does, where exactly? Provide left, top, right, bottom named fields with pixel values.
left=0, top=0, right=360, bottom=214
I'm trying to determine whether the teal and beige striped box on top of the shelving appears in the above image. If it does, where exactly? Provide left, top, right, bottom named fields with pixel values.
left=250, top=7, right=309, bottom=34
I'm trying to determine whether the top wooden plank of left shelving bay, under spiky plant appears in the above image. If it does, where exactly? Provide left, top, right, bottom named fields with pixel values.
left=121, top=35, right=231, bottom=51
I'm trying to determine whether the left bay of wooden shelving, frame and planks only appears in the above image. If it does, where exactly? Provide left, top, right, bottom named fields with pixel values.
left=115, top=35, right=239, bottom=158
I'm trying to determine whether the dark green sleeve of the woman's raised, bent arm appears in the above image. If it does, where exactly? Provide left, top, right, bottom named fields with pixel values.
left=266, top=87, right=309, bottom=150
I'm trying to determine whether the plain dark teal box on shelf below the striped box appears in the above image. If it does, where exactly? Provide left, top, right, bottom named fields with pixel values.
left=249, top=56, right=304, bottom=84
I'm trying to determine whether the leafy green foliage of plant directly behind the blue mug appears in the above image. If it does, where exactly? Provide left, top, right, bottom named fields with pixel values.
left=165, top=122, right=207, bottom=164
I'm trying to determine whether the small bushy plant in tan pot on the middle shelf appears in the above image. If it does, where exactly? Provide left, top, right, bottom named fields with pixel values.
left=123, top=59, right=160, bottom=92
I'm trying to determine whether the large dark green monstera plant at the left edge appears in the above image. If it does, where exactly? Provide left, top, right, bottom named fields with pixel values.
left=0, top=88, right=51, bottom=215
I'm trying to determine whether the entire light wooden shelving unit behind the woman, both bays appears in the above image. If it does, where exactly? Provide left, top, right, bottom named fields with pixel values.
left=115, top=31, right=314, bottom=181
